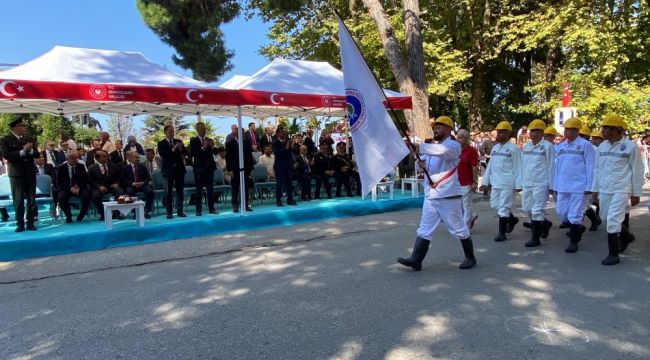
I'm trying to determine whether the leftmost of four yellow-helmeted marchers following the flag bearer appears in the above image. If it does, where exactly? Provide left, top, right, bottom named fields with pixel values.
left=481, top=121, right=521, bottom=242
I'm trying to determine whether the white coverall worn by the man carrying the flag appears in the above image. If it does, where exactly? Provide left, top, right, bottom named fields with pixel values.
left=417, top=137, right=470, bottom=240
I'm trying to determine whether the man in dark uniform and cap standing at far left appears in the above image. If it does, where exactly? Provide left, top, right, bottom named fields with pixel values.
left=0, top=118, right=38, bottom=232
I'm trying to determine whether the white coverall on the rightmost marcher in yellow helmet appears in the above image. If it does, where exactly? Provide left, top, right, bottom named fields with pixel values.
left=592, top=139, right=644, bottom=234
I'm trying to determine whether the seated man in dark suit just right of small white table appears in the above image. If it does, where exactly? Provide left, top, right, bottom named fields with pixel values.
left=122, top=151, right=153, bottom=219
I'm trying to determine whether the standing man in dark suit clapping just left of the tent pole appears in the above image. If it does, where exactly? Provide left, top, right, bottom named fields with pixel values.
left=190, top=122, right=217, bottom=216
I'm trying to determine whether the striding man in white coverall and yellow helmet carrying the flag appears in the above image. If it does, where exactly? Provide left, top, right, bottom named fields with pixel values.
left=397, top=116, right=476, bottom=271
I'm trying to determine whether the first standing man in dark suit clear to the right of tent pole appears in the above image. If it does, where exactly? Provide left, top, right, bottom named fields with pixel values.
left=273, top=127, right=297, bottom=206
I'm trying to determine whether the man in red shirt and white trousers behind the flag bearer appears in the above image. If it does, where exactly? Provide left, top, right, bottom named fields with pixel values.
left=456, top=129, right=479, bottom=230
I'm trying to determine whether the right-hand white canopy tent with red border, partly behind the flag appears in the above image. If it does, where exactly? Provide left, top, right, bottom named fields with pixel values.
left=220, top=59, right=412, bottom=117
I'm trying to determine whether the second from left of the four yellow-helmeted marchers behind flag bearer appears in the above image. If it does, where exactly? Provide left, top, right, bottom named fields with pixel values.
left=521, top=120, right=554, bottom=247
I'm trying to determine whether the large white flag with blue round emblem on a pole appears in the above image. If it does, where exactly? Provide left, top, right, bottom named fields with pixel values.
left=339, top=19, right=409, bottom=195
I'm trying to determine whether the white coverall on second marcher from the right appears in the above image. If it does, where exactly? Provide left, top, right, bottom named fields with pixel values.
left=553, top=137, right=596, bottom=225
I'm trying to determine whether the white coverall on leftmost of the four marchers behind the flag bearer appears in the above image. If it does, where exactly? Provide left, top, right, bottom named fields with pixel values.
left=482, top=141, right=521, bottom=217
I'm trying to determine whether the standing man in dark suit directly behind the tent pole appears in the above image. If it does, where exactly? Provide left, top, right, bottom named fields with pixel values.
left=226, top=132, right=255, bottom=212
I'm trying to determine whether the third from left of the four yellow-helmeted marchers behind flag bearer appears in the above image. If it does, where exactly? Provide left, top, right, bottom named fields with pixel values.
left=553, top=118, right=596, bottom=253
